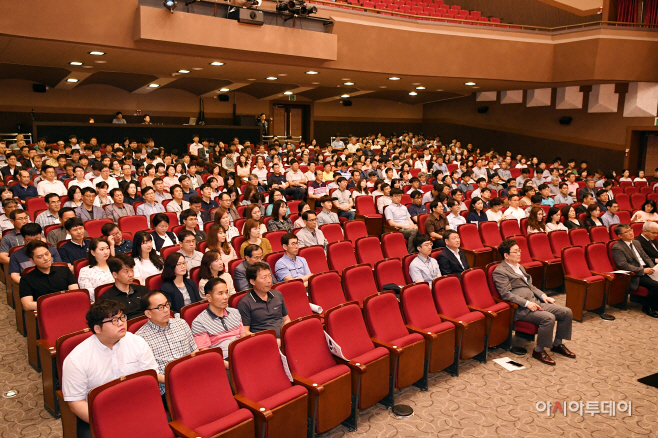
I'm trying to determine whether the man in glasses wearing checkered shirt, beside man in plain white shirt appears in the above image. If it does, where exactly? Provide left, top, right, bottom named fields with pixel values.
left=135, top=291, right=197, bottom=401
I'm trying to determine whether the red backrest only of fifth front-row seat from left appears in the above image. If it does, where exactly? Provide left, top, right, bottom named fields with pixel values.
left=325, top=302, right=375, bottom=359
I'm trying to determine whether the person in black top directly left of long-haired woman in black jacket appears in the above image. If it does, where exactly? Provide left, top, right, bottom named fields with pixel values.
left=98, top=254, right=149, bottom=319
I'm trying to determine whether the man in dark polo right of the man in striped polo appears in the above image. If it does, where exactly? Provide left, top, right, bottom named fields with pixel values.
left=238, top=262, right=290, bottom=342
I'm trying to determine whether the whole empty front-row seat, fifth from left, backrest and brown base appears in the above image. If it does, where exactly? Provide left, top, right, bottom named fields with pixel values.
left=325, top=304, right=393, bottom=410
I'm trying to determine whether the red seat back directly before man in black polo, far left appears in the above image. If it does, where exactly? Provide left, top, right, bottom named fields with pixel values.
left=37, top=290, right=91, bottom=346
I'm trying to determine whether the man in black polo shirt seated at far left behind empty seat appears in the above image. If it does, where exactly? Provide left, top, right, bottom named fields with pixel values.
left=19, top=240, right=79, bottom=310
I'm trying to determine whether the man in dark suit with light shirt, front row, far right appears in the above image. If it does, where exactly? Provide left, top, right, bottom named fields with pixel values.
left=612, top=224, right=658, bottom=318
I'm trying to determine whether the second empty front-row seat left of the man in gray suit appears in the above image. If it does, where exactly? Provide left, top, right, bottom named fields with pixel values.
left=432, top=275, right=488, bottom=362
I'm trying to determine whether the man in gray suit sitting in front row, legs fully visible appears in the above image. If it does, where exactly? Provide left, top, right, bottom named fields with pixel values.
left=493, top=239, right=576, bottom=365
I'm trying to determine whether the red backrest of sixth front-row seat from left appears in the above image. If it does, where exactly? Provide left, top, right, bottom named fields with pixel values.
left=363, top=292, right=409, bottom=342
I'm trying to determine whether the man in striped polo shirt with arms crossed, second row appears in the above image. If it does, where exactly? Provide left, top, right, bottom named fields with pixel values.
left=192, top=278, right=246, bottom=369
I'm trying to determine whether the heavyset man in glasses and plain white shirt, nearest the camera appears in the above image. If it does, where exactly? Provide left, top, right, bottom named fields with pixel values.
left=62, top=300, right=159, bottom=437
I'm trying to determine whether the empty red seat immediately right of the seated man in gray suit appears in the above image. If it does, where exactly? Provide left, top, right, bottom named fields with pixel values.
left=562, top=246, right=605, bottom=322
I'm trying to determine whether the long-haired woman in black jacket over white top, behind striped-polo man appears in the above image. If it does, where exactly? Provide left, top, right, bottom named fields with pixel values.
left=160, top=252, right=201, bottom=313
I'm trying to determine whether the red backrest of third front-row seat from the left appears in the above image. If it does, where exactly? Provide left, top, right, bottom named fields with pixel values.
left=229, top=332, right=292, bottom=401
